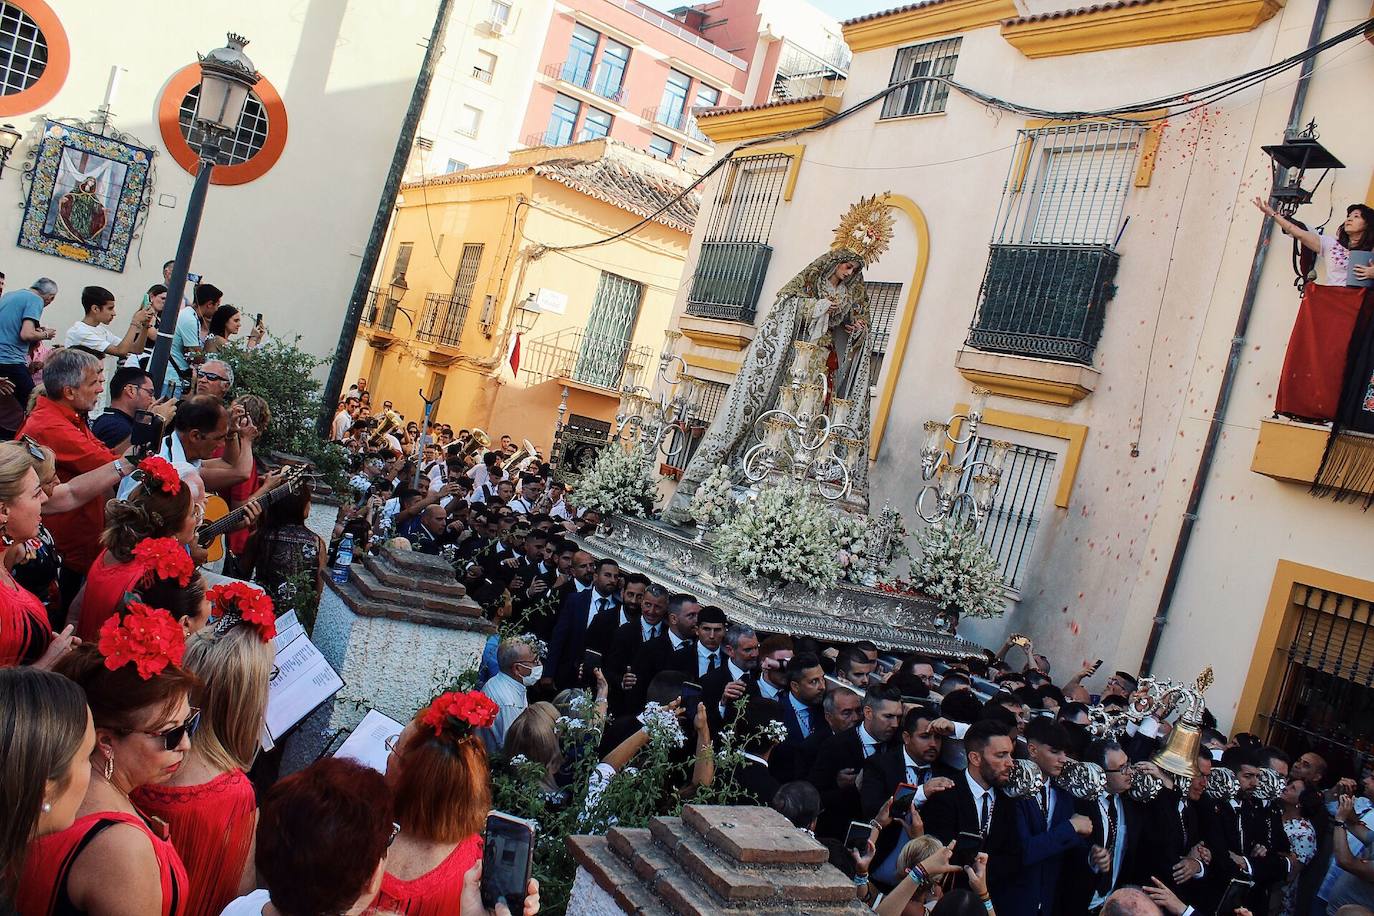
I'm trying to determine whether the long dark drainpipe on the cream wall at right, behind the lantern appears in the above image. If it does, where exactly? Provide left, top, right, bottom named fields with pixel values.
left=1140, top=0, right=1331, bottom=674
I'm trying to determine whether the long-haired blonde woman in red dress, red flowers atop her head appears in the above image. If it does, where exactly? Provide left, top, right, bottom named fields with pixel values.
left=132, top=582, right=276, bottom=916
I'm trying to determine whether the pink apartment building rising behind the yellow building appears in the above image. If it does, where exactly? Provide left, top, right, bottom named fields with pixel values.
left=521, top=0, right=849, bottom=161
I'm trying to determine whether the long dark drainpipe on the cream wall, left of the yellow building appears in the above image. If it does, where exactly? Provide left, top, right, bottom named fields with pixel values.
left=316, top=0, right=453, bottom=439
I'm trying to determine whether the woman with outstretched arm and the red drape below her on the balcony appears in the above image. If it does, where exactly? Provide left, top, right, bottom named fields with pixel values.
left=1254, top=198, right=1374, bottom=423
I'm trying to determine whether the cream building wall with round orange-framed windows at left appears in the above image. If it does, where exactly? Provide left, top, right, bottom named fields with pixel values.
left=0, top=0, right=438, bottom=365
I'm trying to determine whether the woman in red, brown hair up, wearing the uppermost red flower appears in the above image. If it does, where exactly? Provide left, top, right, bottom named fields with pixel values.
left=67, top=456, right=199, bottom=641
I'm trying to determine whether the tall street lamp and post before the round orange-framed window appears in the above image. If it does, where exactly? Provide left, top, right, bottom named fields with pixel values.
left=148, top=32, right=260, bottom=390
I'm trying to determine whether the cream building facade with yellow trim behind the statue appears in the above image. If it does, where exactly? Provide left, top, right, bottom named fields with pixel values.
left=675, top=0, right=1374, bottom=754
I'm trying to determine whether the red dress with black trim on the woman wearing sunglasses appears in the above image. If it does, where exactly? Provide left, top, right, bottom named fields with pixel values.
left=15, top=812, right=190, bottom=916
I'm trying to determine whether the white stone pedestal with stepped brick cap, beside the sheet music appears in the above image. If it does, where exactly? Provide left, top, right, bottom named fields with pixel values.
left=282, top=549, right=496, bottom=776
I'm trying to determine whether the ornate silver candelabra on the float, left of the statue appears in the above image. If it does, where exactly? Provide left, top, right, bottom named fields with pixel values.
left=614, top=330, right=698, bottom=467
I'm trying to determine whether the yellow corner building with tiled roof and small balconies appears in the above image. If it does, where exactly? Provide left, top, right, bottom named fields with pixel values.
left=349, top=140, right=697, bottom=455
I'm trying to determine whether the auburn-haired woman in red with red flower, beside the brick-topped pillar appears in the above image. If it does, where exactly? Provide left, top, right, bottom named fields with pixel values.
left=368, top=691, right=496, bottom=916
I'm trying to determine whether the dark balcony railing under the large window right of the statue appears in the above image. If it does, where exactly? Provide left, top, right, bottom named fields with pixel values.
left=961, top=244, right=1121, bottom=365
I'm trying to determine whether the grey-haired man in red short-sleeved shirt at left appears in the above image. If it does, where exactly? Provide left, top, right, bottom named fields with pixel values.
left=19, top=350, right=132, bottom=618
